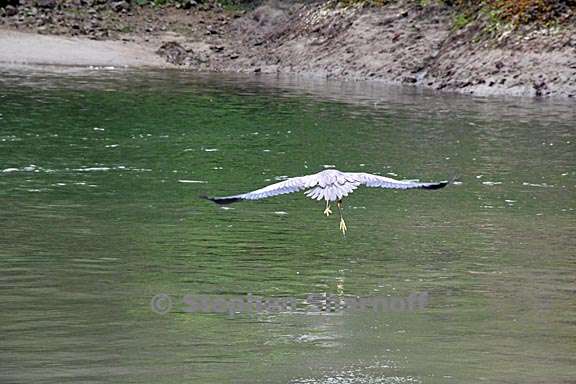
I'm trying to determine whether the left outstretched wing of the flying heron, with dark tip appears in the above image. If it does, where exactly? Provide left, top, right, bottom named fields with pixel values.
left=202, top=175, right=318, bottom=204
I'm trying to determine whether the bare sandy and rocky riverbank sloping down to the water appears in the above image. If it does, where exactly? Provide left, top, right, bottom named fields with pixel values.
left=0, top=1, right=576, bottom=97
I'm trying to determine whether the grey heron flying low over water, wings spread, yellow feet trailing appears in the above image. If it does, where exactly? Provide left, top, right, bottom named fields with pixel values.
left=202, top=169, right=449, bottom=234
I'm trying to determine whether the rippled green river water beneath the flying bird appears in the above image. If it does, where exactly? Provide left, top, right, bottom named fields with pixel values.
left=0, top=71, right=576, bottom=384
